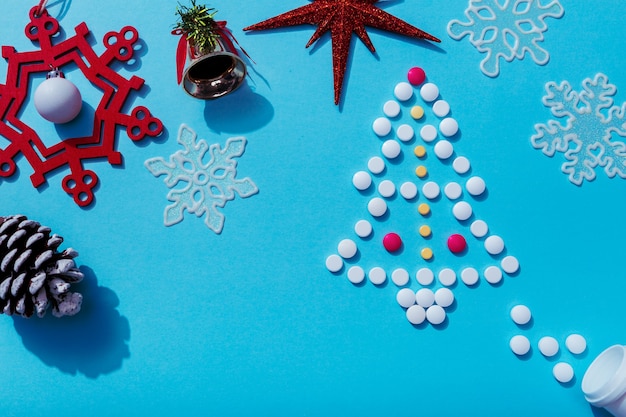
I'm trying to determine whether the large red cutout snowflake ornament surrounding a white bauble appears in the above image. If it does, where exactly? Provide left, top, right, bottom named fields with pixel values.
left=0, top=7, right=163, bottom=207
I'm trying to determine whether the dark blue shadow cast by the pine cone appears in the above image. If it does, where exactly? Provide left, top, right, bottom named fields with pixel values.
left=13, top=266, right=130, bottom=378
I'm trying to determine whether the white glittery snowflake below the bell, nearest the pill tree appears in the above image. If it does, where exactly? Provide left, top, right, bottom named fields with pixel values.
left=145, top=124, right=259, bottom=233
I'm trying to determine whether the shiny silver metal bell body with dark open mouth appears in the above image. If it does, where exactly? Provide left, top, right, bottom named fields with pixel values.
left=182, top=51, right=247, bottom=100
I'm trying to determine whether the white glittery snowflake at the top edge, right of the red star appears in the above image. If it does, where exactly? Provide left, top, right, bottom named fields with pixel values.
left=448, top=0, right=564, bottom=77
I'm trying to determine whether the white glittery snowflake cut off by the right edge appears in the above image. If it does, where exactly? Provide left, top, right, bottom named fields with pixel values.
left=530, top=73, right=626, bottom=185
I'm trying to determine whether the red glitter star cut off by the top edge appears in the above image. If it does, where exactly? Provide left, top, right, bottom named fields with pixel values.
left=243, top=0, right=441, bottom=104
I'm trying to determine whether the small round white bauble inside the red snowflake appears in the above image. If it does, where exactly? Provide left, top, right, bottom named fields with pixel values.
left=34, top=70, right=83, bottom=123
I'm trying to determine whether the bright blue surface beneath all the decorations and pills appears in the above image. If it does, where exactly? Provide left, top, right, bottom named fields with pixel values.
left=0, top=0, right=626, bottom=417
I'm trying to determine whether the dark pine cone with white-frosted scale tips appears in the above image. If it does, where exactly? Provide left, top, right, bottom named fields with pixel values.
left=0, top=215, right=83, bottom=317
